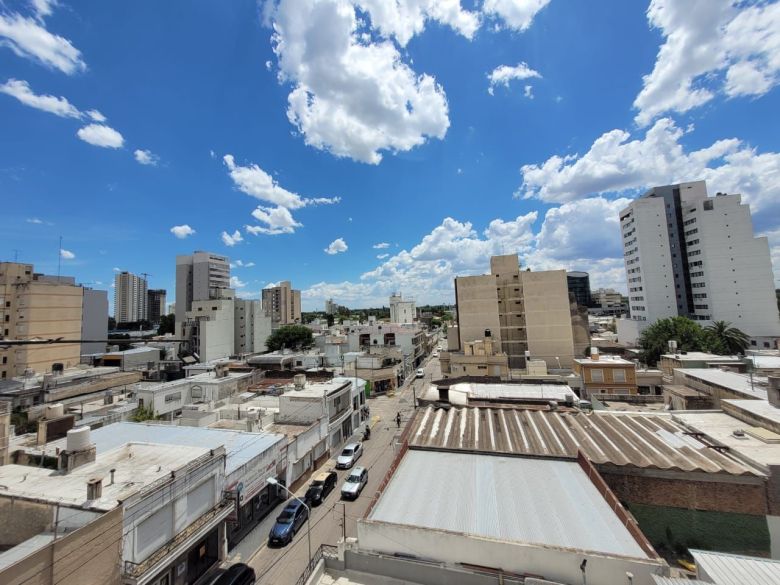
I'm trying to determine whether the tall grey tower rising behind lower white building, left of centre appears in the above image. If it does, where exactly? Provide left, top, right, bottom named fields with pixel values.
left=176, top=252, right=230, bottom=335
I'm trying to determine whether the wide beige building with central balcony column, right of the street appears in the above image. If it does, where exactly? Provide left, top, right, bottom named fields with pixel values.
left=455, top=254, right=574, bottom=368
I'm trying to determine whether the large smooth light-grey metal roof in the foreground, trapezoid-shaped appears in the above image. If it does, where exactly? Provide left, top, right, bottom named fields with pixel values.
left=369, top=450, right=648, bottom=559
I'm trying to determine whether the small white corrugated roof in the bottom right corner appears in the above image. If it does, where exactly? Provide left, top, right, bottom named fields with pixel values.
left=690, top=550, right=780, bottom=585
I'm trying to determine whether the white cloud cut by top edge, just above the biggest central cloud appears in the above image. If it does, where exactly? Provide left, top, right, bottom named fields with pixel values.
left=356, top=0, right=480, bottom=47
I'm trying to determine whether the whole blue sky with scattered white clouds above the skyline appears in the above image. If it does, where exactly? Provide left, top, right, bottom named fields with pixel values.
left=0, top=0, right=780, bottom=309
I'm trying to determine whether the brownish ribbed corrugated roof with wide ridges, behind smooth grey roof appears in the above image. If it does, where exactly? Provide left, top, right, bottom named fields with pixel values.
left=410, top=407, right=761, bottom=475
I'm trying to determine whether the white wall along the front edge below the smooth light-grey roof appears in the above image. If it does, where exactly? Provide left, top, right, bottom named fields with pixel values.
left=357, top=520, right=669, bottom=585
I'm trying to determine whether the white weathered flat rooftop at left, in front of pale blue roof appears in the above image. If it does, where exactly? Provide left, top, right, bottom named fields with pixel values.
left=0, top=442, right=210, bottom=512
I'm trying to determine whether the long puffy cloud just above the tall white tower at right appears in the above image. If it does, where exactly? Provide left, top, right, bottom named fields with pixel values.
left=517, top=118, right=780, bottom=216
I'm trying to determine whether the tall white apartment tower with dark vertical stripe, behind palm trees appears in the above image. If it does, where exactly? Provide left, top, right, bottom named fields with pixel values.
left=618, top=181, right=780, bottom=347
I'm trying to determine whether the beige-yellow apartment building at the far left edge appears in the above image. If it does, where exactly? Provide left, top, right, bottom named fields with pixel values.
left=0, top=262, right=84, bottom=379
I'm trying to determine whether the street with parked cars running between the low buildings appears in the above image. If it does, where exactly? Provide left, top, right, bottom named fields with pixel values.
left=229, top=350, right=441, bottom=585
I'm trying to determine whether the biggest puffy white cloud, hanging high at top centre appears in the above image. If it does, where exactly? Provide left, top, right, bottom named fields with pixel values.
left=270, top=0, right=452, bottom=164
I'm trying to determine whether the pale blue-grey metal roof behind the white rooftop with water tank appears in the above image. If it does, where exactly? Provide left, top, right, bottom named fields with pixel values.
left=36, top=421, right=287, bottom=474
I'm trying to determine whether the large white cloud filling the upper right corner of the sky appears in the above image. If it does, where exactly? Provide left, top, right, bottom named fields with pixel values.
left=634, top=0, right=780, bottom=126
